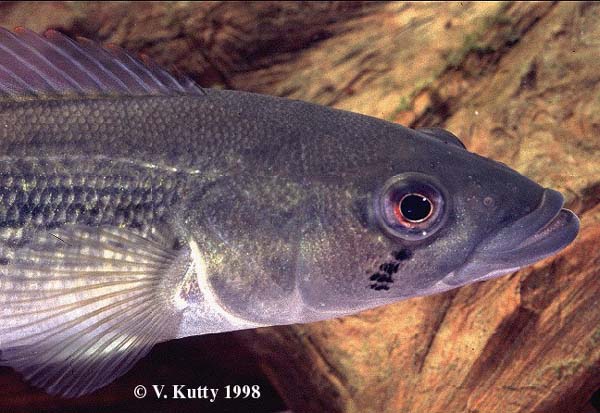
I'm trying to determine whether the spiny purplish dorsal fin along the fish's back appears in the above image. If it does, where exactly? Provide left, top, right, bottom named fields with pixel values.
left=0, top=27, right=202, bottom=98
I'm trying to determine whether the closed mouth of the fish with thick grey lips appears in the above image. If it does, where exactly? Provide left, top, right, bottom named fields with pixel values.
left=443, top=189, right=579, bottom=286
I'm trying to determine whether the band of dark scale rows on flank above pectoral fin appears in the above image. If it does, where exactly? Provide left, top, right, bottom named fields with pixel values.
left=0, top=159, right=188, bottom=244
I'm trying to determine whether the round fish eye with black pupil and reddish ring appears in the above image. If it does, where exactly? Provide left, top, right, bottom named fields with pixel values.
left=375, top=173, right=446, bottom=241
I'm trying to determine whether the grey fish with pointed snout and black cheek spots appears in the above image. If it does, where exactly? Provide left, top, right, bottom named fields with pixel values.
left=0, top=28, right=579, bottom=397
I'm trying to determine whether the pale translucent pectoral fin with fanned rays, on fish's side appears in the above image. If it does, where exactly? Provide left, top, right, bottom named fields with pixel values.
left=0, top=226, right=189, bottom=397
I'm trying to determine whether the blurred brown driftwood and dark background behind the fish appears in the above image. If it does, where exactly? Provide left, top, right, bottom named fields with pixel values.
left=0, top=2, right=600, bottom=413
